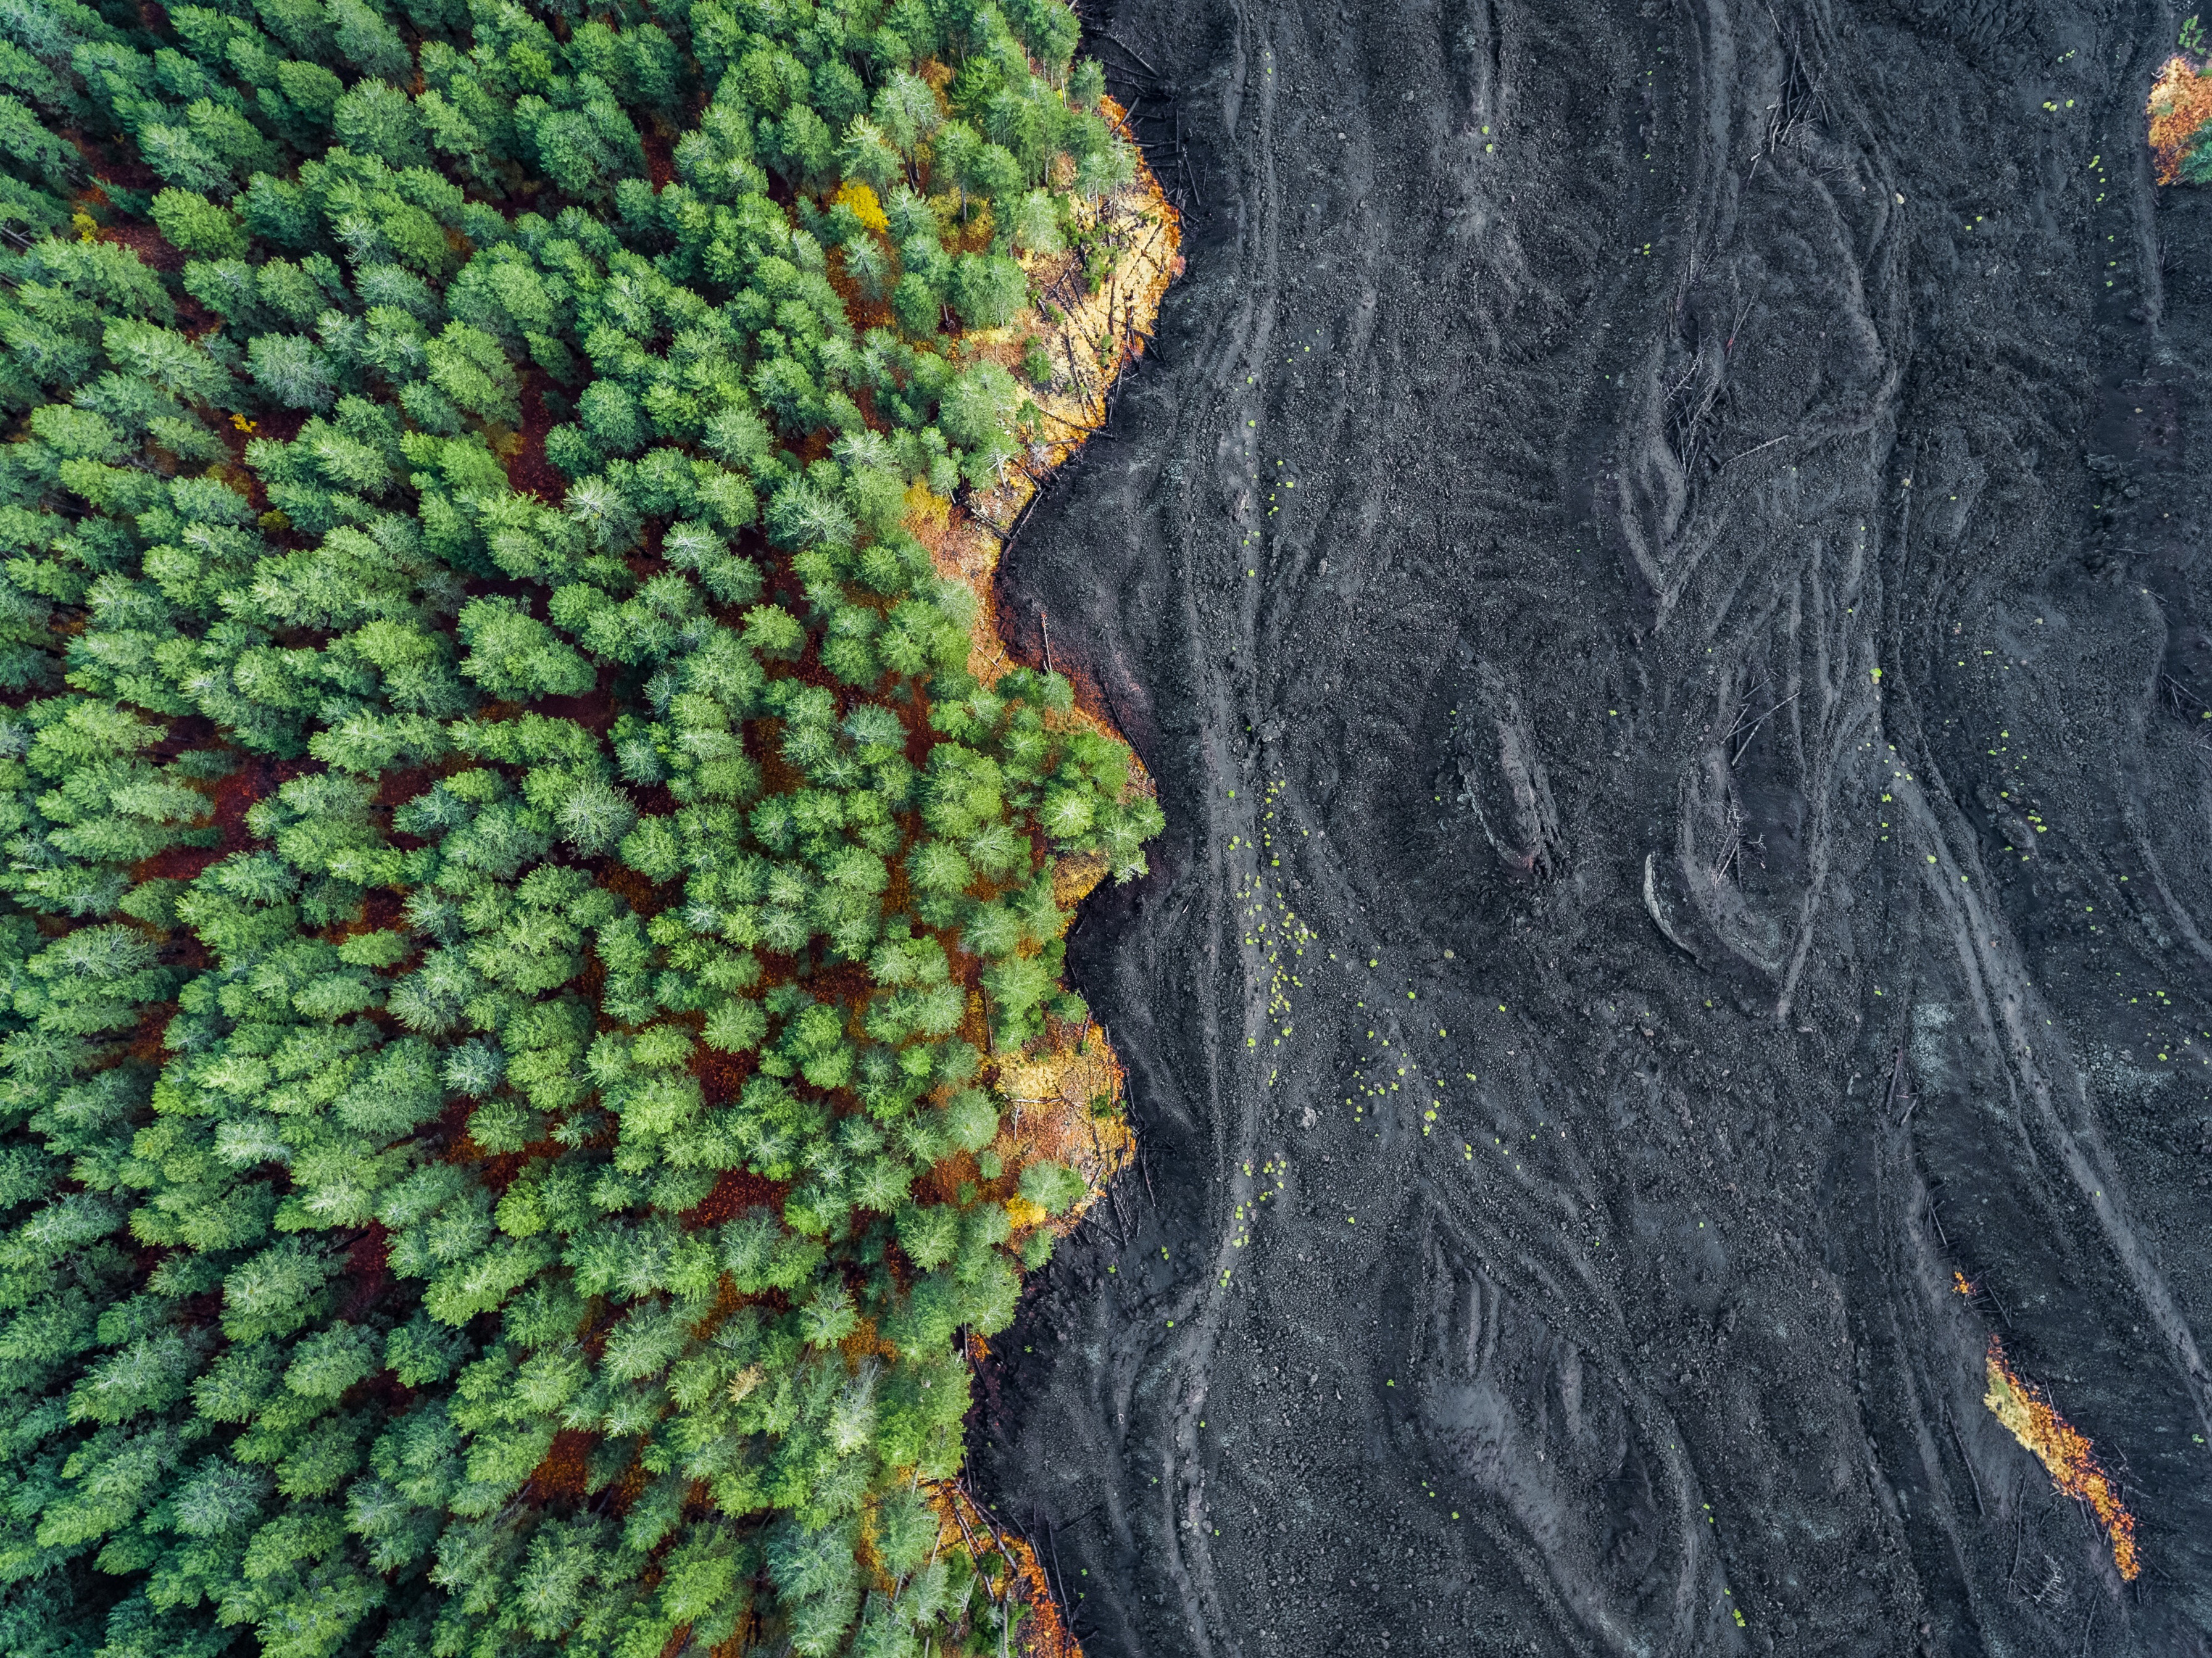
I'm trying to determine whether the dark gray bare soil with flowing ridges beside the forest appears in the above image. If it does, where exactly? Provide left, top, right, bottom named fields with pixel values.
left=973, top=0, right=2212, bottom=1658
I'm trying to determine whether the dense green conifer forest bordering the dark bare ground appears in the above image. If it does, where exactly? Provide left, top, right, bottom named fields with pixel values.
left=0, top=0, right=1162, bottom=1658
